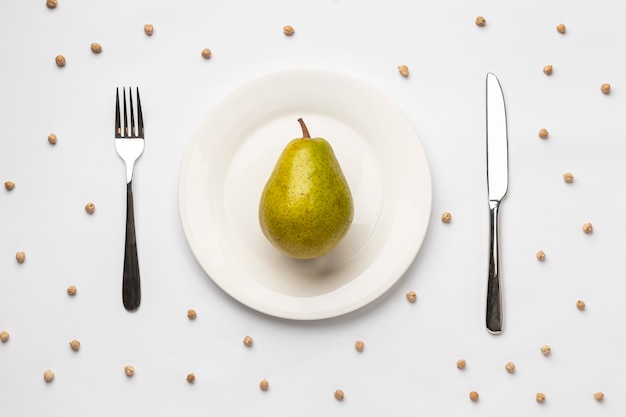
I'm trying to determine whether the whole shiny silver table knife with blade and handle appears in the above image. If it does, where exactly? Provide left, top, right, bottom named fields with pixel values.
left=486, top=73, right=509, bottom=334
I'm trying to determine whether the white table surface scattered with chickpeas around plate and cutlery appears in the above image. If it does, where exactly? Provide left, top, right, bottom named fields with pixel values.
left=0, top=0, right=626, bottom=416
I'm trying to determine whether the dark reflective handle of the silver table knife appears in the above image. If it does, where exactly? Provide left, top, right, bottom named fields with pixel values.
left=486, top=200, right=503, bottom=334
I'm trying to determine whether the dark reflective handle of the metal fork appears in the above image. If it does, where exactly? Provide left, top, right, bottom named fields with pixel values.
left=122, top=180, right=141, bottom=311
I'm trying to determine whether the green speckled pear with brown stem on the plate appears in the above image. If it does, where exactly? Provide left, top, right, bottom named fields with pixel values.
left=259, top=119, right=354, bottom=259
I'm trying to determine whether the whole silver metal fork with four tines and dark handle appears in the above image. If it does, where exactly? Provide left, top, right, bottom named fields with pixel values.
left=115, top=87, right=144, bottom=311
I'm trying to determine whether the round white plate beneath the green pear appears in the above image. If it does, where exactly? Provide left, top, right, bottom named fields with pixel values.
left=179, top=70, right=431, bottom=320
